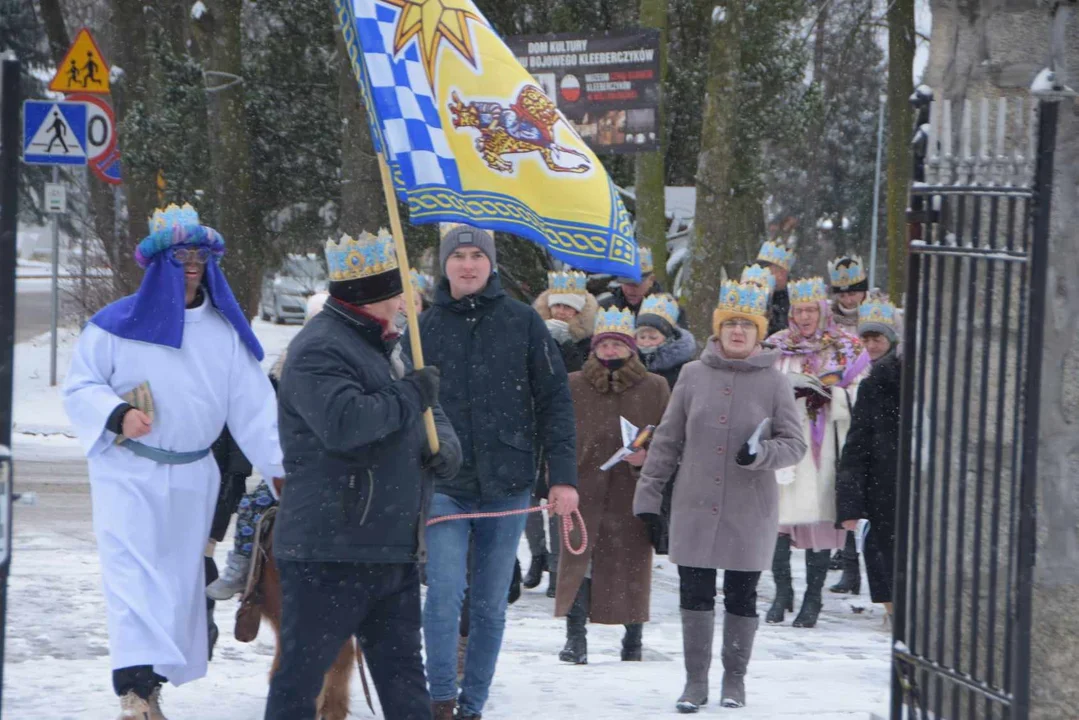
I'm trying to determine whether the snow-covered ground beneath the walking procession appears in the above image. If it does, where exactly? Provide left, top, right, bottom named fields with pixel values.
left=2, top=323, right=890, bottom=720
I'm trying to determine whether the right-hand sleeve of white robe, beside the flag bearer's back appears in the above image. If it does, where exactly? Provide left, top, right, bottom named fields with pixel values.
left=227, top=337, right=285, bottom=487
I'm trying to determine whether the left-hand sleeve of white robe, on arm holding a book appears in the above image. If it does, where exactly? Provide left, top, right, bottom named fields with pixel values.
left=62, top=324, right=123, bottom=457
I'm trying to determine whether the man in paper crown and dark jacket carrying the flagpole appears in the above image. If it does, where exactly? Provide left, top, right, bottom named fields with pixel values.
left=265, top=233, right=461, bottom=720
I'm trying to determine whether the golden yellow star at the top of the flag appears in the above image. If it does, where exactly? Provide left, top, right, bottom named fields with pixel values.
left=383, top=0, right=486, bottom=86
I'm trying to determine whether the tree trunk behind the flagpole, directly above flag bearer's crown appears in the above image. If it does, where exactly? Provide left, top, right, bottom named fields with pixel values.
left=333, top=13, right=392, bottom=235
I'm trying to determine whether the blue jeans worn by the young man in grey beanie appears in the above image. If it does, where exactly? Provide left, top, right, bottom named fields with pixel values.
left=423, top=491, right=531, bottom=715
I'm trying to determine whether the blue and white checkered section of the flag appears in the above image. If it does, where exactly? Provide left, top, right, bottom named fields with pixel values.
left=353, top=0, right=461, bottom=191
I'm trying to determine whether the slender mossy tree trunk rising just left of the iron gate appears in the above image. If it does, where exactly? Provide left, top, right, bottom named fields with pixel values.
left=886, top=0, right=915, bottom=301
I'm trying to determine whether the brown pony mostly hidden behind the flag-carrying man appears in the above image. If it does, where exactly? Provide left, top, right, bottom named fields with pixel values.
left=235, top=508, right=374, bottom=720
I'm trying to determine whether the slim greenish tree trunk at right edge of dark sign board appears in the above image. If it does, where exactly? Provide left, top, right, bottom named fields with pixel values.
left=633, top=0, right=671, bottom=290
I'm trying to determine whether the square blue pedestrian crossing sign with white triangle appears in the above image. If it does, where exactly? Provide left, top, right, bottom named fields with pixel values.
left=23, top=100, right=86, bottom=165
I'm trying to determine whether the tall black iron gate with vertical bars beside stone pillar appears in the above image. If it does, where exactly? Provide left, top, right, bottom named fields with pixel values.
left=891, top=92, right=1057, bottom=720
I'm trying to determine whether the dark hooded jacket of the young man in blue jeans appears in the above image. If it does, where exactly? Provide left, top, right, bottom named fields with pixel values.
left=420, top=274, right=577, bottom=499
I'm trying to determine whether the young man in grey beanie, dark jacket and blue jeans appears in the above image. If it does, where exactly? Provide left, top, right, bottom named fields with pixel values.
left=420, top=226, right=577, bottom=720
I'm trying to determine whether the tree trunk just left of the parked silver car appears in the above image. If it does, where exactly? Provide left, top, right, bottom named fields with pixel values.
left=194, top=0, right=265, bottom=317
